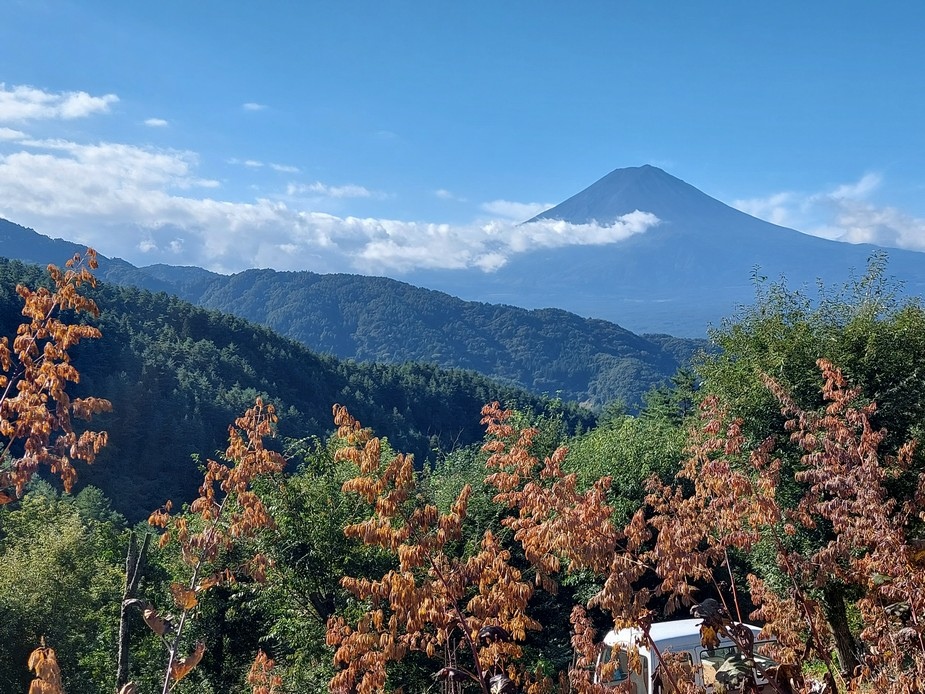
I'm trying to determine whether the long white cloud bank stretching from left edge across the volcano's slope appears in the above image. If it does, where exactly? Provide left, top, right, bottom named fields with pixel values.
left=0, top=133, right=658, bottom=273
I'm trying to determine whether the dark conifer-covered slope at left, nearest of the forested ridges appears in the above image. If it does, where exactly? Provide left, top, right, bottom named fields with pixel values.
left=0, top=259, right=593, bottom=520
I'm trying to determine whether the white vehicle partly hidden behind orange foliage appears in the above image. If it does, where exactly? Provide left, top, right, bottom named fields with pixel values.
left=594, top=619, right=776, bottom=694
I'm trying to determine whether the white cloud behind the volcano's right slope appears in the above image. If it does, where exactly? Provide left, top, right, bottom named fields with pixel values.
left=732, top=173, right=925, bottom=251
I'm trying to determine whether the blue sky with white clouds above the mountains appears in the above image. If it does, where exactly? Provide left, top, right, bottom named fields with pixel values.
left=0, top=0, right=925, bottom=275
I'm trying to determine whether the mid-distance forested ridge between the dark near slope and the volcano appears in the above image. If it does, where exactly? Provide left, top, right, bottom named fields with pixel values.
left=0, top=220, right=706, bottom=405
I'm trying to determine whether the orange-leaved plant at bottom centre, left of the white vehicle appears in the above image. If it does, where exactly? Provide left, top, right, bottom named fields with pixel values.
left=327, top=406, right=540, bottom=692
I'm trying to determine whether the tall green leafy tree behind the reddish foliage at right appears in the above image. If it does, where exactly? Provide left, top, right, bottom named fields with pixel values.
left=698, top=256, right=925, bottom=670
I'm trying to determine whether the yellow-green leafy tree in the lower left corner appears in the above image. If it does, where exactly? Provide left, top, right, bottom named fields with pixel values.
left=0, top=483, right=125, bottom=694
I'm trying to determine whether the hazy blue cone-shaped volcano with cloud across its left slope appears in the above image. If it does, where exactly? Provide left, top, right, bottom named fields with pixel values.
left=403, top=166, right=925, bottom=336
